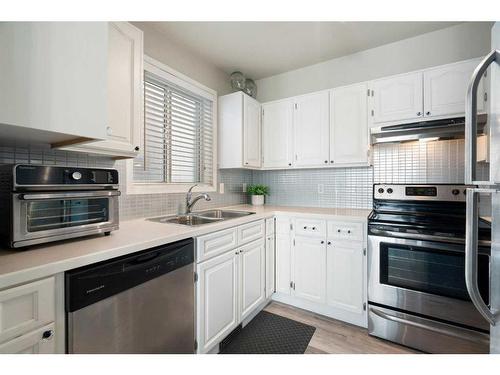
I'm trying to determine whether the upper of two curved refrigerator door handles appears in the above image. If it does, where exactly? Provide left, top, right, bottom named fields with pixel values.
left=465, top=49, right=500, bottom=185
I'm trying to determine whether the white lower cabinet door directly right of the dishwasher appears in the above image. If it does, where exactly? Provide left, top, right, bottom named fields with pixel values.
left=197, top=250, right=239, bottom=353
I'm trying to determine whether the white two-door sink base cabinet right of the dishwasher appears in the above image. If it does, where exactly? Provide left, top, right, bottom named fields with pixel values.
left=196, top=220, right=266, bottom=353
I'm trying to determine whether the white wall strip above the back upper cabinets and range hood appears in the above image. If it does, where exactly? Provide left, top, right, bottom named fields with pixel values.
left=256, top=22, right=492, bottom=102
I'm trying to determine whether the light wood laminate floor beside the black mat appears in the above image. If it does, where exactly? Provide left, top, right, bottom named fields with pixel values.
left=264, top=302, right=418, bottom=354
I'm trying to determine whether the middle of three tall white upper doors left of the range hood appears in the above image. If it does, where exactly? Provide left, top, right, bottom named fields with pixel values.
left=293, top=91, right=330, bottom=167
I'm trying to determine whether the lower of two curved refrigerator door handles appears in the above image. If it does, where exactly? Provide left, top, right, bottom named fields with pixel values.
left=465, top=188, right=499, bottom=326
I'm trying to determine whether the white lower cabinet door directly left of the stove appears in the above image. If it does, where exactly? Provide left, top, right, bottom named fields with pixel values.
left=326, top=241, right=364, bottom=314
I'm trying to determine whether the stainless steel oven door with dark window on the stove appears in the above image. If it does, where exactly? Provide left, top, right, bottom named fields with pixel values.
left=368, top=235, right=490, bottom=330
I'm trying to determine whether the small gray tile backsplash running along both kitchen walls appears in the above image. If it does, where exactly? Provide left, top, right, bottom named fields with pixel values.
left=0, top=140, right=488, bottom=220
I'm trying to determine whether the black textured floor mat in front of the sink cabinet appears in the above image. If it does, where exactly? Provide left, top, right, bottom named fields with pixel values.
left=220, top=311, right=316, bottom=354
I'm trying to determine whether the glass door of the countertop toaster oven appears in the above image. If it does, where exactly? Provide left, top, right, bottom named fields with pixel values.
left=11, top=190, right=120, bottom=247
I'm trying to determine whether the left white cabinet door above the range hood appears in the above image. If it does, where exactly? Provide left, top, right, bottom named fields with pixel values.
left=373, top=72, right=424, bottom=123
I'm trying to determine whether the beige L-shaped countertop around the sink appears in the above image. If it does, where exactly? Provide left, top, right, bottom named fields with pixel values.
left=0, top=205, right=370, bottom=289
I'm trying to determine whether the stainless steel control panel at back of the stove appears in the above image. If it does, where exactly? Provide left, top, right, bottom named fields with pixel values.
left=373, top=184, right=467, bottom=202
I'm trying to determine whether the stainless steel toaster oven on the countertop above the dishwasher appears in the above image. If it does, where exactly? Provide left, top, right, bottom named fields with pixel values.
left=0, top=164, right=120, bottom=248
